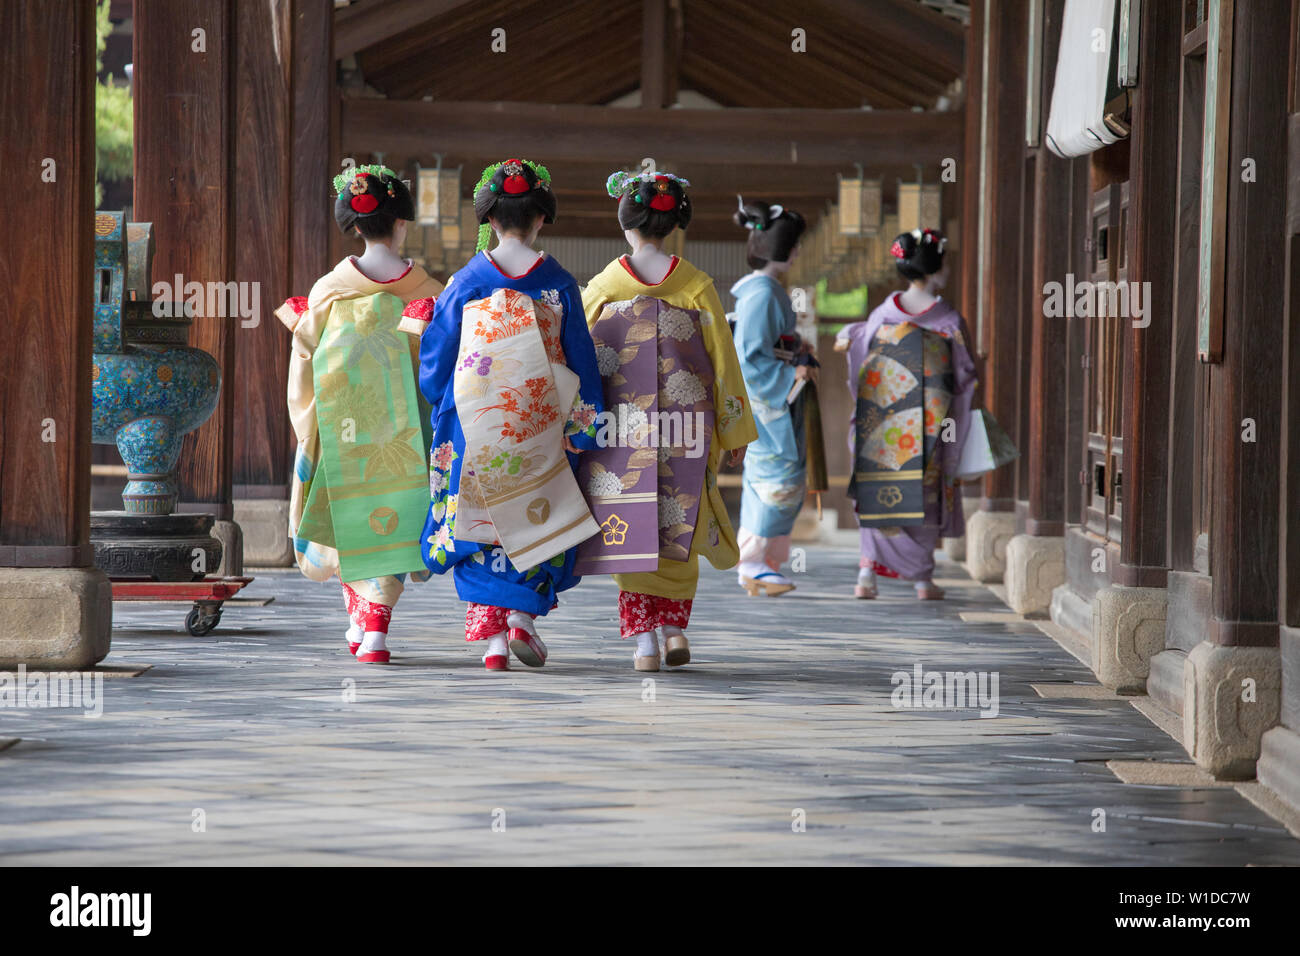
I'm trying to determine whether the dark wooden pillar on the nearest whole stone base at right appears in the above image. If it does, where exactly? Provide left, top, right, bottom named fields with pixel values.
left=1209, top=0, right=1291, bottom=646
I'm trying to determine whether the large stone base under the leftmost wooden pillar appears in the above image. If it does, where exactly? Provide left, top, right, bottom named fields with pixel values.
left=0, top=567, right=113, bottom=670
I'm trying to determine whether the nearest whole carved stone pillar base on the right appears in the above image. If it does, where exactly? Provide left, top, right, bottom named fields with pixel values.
left=1183, top=641, right=1287, bottom=780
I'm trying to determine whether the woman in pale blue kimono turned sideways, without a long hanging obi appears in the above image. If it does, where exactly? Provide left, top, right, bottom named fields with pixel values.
left=732, top=200, right=814, bottom=597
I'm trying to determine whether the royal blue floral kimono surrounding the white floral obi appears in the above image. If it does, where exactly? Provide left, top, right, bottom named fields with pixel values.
left=420, top=252, right=603, bottom=615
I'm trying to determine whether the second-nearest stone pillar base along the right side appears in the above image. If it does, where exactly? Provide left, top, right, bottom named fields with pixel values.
left=1092, top=585, right=1169, bottom=693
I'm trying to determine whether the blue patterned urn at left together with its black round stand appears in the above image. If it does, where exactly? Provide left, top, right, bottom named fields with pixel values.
left=91, top=212, right=222, bottom=580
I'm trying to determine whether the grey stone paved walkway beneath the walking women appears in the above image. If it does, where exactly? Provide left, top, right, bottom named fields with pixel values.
left=0, top=548, right=1300, bottom=865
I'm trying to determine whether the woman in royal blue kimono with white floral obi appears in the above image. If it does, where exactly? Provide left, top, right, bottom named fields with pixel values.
left=420, top=159, right=602, bottom=670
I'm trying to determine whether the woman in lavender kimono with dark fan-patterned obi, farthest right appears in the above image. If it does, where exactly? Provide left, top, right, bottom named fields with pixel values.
left=836, top=229, right=976, bottom=601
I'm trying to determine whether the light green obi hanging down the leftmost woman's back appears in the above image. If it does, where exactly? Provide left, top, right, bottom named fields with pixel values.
left=298, top=293, right=429, bottom=581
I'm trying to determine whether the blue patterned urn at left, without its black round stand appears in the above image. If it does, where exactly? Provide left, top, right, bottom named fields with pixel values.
left=91, top=212, right=221, bottom=515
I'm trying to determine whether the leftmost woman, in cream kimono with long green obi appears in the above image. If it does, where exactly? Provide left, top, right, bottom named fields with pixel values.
left=276, top=165, right=442, bottom=663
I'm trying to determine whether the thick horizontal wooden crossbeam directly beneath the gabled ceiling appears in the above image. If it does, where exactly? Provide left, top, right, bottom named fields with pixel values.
left=342, top=99, right=962, bottom=168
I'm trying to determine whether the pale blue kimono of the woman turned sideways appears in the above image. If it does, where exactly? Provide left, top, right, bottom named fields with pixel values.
left=732, top=273, right=807, bottom=538
